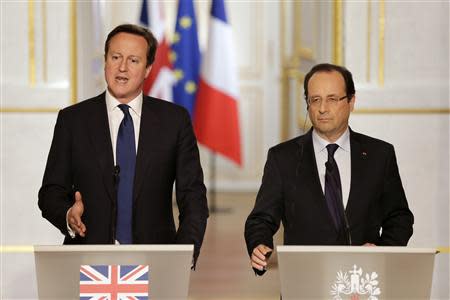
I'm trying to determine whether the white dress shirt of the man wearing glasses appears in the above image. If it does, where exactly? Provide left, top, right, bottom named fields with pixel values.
left=312, top=128, right=351, bottom=208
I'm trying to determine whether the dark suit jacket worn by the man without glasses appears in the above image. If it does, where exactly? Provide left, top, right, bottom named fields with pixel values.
left=39, top=93, right=208, bottom=257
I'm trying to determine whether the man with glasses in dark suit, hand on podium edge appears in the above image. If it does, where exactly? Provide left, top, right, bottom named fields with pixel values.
left=245, top=64, right=414, bottom=274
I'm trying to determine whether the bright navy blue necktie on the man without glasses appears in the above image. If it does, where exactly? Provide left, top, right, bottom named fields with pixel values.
left=116, top=104, right=136, bottom=244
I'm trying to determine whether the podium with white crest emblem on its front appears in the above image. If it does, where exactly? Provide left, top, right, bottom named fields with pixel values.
left=277, top=246, right=437, bottom=300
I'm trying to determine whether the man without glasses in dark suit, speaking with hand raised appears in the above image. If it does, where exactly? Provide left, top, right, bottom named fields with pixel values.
left=39, top=24, right=208, bottom=258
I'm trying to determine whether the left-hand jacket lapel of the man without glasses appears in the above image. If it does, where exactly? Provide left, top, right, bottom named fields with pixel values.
left=88, top=93, right=116, bottom=199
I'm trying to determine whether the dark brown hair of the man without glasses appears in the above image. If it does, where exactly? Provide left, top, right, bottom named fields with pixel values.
left=105, top=24, right=158, bottom=67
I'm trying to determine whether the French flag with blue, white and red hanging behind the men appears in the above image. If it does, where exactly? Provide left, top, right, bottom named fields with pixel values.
left=193, top=0, right=242, bottom=165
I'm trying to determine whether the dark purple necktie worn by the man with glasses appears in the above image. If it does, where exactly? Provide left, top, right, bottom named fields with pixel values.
left=325, top=144, right=342, bottom=230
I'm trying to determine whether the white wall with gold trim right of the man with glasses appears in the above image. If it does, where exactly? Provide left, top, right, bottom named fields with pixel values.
left=344, top=1, right=450, bottom=299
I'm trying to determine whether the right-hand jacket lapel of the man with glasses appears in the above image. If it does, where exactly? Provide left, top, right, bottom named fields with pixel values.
left=346, top=130, right=368, bottom=224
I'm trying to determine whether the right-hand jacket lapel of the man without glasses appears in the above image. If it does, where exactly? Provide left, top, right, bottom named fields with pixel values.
left=133, top=96, right=163, bottom=199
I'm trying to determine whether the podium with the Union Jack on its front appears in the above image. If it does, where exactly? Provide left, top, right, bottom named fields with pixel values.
left=34, top=245, right=194, bottom=300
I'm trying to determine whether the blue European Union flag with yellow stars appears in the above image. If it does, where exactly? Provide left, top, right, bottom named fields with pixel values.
left=171, top=0, right=200, bottom=118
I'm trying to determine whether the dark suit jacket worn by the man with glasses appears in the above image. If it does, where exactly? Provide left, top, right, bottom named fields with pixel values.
left=245, top=130, right=414, bottom=254
